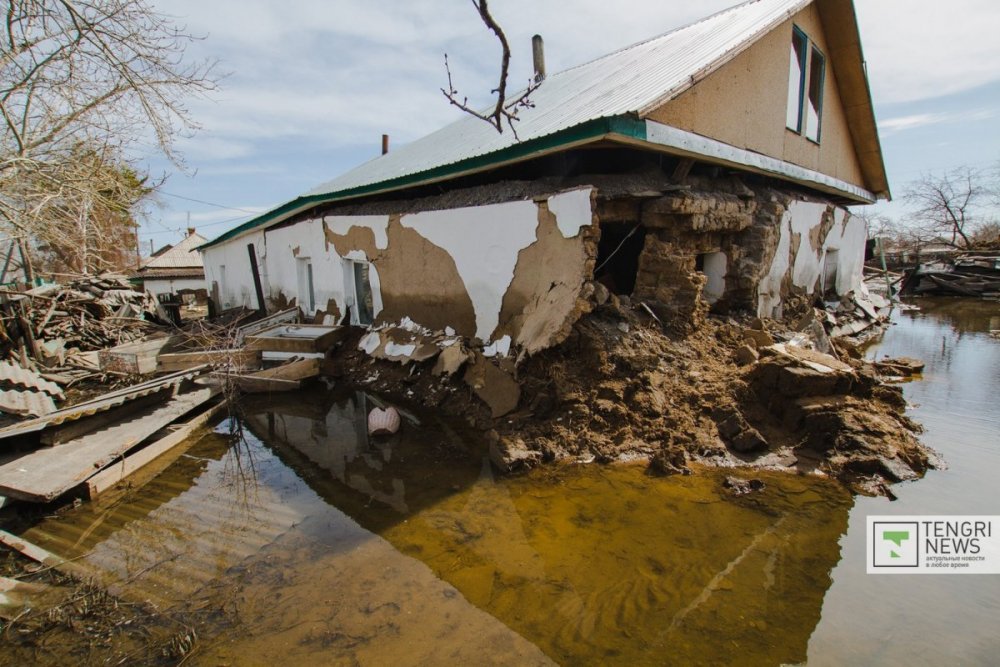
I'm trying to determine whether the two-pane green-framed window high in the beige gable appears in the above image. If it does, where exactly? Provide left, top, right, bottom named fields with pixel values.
left=785, top=27, right=826, bottom=143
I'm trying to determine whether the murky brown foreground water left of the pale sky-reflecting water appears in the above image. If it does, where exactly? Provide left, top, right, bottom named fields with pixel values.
left=29, top=384, right=853, bottom=665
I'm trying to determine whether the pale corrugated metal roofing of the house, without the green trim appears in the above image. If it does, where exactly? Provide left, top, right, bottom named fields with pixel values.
left=307, top=0, right=810, bottom=195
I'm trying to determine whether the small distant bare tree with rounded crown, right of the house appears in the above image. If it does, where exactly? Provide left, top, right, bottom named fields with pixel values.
left=904, top=167, right=995, bottom=249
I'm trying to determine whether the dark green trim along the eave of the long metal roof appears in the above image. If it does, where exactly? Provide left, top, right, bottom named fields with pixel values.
left=198, top=115, right=646, bottom=250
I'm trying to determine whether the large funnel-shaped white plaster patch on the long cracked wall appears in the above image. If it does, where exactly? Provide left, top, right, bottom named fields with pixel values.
left=400, top=201, right=544, bottom=342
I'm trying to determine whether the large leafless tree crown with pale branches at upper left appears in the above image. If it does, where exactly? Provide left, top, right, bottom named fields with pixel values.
left=0, top=0, right=215, bottom=276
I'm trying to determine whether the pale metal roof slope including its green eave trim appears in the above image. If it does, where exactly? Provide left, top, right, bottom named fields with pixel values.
left=201, top=0, right=866, bottom=249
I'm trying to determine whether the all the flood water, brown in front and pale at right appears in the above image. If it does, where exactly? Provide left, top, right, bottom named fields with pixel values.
left=13, top=300, right=1000, bottom=665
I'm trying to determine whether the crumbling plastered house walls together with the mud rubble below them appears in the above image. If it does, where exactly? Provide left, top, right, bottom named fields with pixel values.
left=206, top=173, right=934, bottom=493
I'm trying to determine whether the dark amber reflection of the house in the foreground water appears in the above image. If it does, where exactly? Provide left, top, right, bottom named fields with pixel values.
left=236, top=394, right=851, bottom=664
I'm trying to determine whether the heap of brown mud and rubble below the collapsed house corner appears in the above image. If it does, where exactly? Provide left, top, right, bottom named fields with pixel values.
left=337, top=297, right=938, bottom=496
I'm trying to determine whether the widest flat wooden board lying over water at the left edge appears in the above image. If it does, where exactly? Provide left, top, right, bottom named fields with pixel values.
left=0, top=387, right=219, bottom=502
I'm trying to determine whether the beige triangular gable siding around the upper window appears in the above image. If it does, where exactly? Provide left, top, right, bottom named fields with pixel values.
left=648, top=5, right=869, bottom=188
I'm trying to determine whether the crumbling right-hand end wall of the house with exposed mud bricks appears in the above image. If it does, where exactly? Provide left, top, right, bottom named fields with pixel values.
left=595, top=179, right=867, bottom=330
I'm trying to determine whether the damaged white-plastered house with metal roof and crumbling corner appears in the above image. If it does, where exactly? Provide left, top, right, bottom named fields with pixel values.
left=202, top=0, right=889, bottom=354
